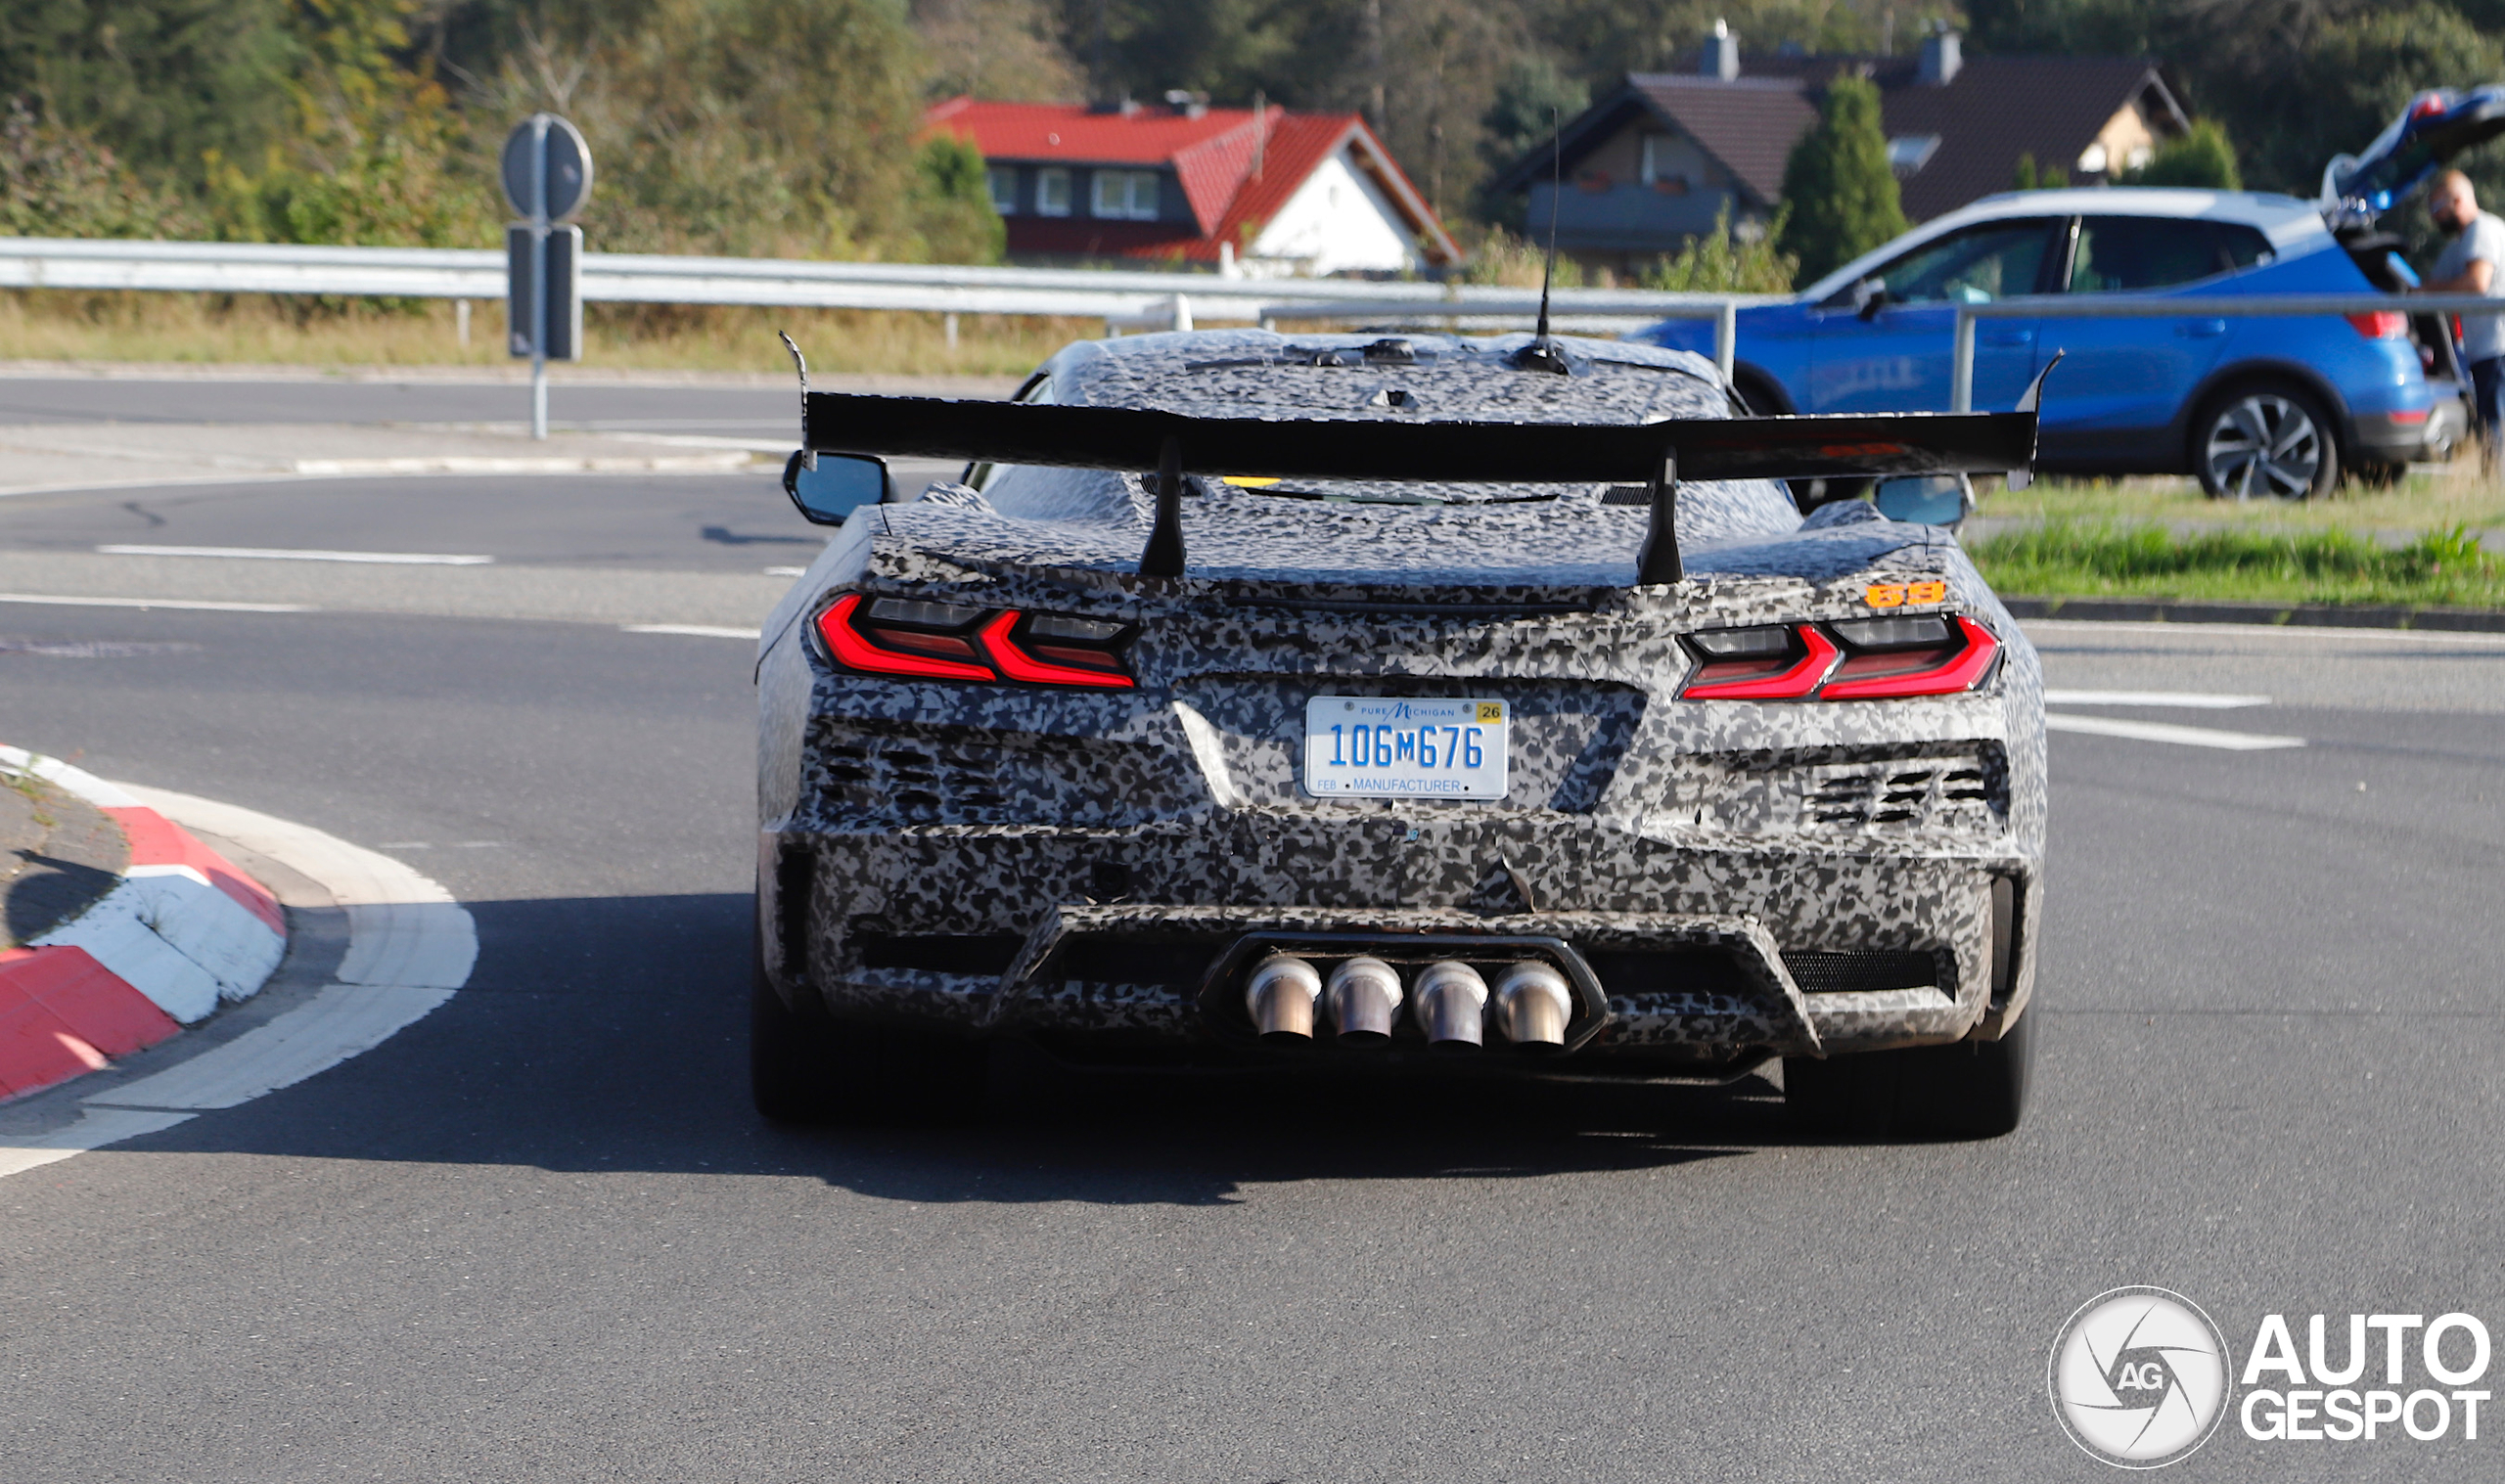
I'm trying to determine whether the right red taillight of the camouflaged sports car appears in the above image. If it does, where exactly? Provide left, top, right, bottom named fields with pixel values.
left=1681, top=615, right=2001, bottom=700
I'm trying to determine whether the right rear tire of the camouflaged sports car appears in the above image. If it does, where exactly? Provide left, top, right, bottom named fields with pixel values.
left=1784, top=1013, right=2034, bottom=1139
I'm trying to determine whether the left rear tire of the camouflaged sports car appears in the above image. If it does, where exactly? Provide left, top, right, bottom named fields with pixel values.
left=749, top=930, right=989, bottom=1124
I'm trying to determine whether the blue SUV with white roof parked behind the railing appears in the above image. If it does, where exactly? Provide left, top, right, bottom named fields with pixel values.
left=1636, top=188, right=2468, bottom=498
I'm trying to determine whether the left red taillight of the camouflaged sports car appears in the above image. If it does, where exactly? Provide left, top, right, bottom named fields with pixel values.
left=817, top=593, right=1132, bottom=691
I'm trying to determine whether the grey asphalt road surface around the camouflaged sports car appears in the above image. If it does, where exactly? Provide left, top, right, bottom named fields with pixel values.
left=0, top=465, right=2505, bottom=1481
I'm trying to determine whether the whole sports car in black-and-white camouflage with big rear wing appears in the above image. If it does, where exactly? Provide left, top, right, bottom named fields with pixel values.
left=754, top=331, right=2044, bottom=1136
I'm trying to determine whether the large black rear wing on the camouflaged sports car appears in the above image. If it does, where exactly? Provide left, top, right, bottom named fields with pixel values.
left=801, top=365, right=2052, bottom=583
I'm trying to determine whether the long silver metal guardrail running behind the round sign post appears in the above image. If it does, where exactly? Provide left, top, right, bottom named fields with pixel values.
left=0, top=238, right=1771, bottom=348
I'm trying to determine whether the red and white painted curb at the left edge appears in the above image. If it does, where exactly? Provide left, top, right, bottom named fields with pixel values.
left=0, top=748, right=288, bottom=1099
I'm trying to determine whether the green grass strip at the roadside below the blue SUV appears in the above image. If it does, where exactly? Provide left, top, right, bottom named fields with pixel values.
left=1967, top=518, right=2505, bottom=608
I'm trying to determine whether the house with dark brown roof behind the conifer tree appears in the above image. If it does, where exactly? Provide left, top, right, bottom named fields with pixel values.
left=1493, top=22, right=2189, bottom=270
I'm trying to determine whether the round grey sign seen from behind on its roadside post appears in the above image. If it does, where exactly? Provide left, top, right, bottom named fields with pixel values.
left=498, top=112, right=591, bottom=438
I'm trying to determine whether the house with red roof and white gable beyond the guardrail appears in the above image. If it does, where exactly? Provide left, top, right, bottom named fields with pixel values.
left=922, top=93, right=1460, bottom=275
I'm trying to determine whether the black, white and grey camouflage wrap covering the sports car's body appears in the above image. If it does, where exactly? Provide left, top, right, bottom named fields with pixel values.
left=756, top=333, right=2047, bottom=1068
